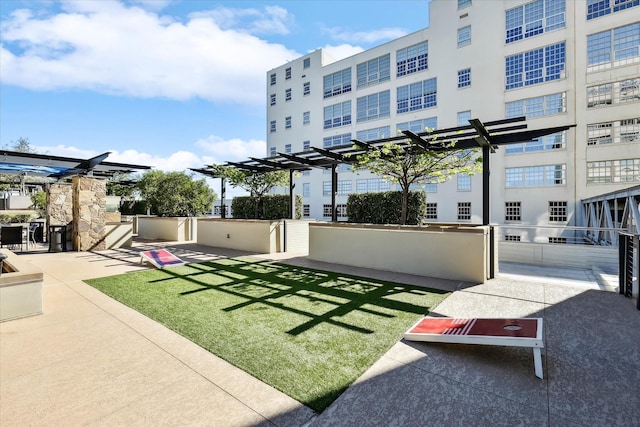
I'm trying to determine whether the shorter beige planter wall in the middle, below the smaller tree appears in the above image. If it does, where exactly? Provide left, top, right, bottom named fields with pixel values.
left=197, top=218, right=284, bottom=253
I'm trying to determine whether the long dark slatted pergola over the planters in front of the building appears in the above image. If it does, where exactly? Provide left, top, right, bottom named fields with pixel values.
left=192, top=117, right=575, bottom=225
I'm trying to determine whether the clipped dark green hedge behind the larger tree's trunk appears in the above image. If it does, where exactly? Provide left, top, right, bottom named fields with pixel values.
left=347, top=191, right=427, bottom=225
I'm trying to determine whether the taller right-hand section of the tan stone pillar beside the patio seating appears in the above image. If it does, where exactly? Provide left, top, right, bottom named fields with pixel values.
left=73, top=176, right=107, bottom=251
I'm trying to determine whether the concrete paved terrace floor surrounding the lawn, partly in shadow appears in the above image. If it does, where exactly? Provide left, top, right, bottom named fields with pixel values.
left=0, top=242, right=640, bottom=427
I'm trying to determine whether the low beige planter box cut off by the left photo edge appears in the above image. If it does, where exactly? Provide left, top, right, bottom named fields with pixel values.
left=0, top=249, right=44, bottom=322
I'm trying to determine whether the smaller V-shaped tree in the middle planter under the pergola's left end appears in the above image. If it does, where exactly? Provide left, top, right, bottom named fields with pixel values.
left=212, top=165, right=289, bottom=218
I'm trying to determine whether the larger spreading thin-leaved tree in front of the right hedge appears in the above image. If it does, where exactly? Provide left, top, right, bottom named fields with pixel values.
left=353, top=135, right=482, bottom=224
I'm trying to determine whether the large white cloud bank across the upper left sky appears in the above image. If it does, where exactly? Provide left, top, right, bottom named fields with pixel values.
left=0, top=0, right=300, bottom=105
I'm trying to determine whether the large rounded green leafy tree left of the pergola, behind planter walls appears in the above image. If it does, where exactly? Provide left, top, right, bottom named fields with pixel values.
left=136, top=170, right=217, bottom=216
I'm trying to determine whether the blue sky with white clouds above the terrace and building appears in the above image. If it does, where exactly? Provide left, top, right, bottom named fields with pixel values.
left=0, top=0, right=432, bottom=193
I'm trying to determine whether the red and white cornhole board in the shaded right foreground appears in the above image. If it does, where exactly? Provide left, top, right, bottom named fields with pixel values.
left=404, top=316, right=544, bottom=378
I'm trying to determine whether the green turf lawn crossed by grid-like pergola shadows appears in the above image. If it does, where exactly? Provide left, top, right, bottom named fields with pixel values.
left=87, top=257, right=448, bottom=412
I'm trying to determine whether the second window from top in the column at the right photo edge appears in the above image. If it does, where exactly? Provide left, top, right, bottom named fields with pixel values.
left=587, top=22, right=640, bottom=71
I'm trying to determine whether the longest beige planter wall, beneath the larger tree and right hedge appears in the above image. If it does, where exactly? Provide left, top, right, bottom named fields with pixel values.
left=309, top=223, right=489, bottom=283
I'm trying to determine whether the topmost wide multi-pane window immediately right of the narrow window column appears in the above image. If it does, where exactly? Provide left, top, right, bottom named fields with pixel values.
left=505, top=0, right=565, bottom=43
